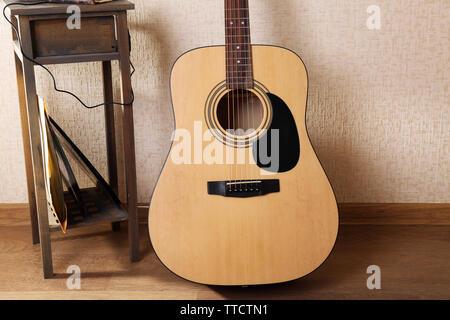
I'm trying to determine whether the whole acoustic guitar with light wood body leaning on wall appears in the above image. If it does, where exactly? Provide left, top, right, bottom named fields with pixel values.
left=149, top=0, right=338, bottom=285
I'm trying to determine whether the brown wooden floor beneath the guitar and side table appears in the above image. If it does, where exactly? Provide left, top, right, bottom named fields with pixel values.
left=0, top=208, right=450, bottom=299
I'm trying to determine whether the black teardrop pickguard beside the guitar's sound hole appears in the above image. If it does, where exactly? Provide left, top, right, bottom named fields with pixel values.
left=253, top=93, right=300, bottom=172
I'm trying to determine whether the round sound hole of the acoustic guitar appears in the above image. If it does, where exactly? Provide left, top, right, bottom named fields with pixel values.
left=217, top=89, right=264, bottom=136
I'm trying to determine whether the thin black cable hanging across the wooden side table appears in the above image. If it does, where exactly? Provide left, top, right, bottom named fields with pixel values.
left=3, top=1, right=136, bottom=109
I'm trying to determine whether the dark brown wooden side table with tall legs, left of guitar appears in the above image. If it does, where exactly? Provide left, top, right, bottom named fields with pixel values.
left=3, top=0, right=139, bottom=278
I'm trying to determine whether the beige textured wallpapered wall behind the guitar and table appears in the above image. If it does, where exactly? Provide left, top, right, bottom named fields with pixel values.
left=0, top=0, right=450, bottom=202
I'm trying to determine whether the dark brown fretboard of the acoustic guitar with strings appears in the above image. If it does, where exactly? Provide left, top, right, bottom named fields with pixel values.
left=225, top=0, right=253, bottom=89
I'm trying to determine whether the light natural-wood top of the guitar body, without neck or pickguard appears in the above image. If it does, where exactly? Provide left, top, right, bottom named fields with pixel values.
left=149, top=45, right=338, bottom=285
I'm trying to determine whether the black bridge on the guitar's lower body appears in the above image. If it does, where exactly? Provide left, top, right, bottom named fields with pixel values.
left=208, top=179, right=280, bottom=198
